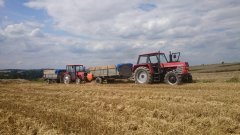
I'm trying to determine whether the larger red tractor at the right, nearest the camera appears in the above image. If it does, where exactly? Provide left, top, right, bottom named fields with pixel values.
left=133, top=52, right=192, bottom=85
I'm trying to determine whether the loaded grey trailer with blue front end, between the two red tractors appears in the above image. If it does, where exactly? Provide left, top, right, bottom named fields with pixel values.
left=89, top=63, right=133, bottom=83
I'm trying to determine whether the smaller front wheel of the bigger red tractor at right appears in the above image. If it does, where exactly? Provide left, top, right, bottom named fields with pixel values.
left=164, top=71, right=182, bottom=85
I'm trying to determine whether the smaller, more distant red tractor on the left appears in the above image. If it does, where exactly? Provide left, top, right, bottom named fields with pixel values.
left=63, top=65, right=93, bottom=84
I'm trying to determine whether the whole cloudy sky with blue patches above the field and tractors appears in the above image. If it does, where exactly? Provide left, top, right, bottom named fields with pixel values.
left=0, top=0, right=240, bottom=69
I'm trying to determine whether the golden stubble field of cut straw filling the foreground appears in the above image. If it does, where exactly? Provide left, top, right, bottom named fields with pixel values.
left=0, top=82, right=240, bottom=135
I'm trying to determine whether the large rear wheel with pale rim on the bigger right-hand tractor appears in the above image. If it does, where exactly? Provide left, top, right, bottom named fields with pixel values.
left=134, top=67, right=152, bottom=84
